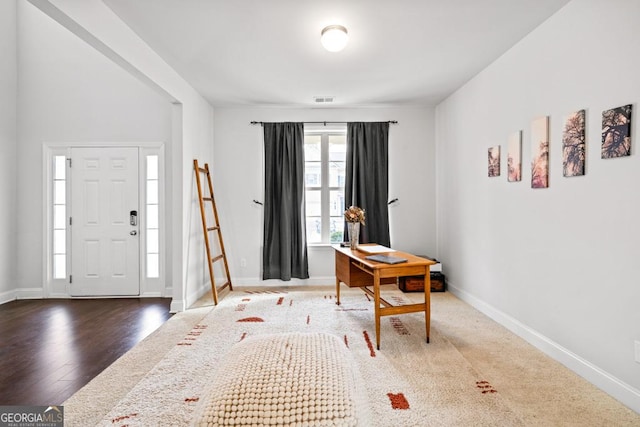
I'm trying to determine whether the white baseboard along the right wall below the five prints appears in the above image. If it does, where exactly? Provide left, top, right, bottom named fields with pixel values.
left=447, top=281, right=640, bottom=413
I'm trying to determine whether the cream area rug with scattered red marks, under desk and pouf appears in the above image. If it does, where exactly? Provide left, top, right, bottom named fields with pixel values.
left=65, top=287, right=640, bottom=427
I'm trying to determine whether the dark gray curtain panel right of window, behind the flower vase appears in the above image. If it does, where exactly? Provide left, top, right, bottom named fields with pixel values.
left=344, top=122, right=391, bottom=247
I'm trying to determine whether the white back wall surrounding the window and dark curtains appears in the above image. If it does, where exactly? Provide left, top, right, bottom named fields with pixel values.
left=211, top=108, right=436, bottom=284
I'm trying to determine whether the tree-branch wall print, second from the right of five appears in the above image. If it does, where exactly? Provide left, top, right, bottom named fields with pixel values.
left=562, top=110, right=586, bottom=176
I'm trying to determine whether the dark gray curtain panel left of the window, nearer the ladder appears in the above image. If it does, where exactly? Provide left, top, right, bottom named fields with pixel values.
left=262, top=123, right=309, bottom=280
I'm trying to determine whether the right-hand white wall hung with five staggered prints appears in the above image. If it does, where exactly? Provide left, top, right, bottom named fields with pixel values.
left=436, top=0, right=640, bottom=411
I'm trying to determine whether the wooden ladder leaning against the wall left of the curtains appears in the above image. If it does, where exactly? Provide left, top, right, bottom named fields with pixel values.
left=193, top=159, right=233, bottom=305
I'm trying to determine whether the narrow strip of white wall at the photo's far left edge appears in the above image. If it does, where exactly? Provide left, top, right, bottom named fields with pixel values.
left=0, top=0, right=18, bottom=303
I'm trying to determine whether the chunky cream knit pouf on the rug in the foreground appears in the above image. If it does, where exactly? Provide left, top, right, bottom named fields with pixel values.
left=196, top=333, right=359, bottom=426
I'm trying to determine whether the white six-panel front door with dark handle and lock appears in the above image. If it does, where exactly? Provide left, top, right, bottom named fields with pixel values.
left=69, top=147, right=140, bottom=296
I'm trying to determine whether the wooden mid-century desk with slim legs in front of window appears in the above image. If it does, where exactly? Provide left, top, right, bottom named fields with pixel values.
left=333, top=245, right=435, bottom=350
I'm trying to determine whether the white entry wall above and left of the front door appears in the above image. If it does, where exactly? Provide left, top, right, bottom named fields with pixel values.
left=16, top=1, right=171, bottom=296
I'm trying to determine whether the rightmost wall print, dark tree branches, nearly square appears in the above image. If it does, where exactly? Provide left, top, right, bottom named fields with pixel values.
left=601, top=105, right=632, bottom=159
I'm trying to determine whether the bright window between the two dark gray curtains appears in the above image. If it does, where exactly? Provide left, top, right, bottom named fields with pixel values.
left=304, top=131, right=347, bottom=244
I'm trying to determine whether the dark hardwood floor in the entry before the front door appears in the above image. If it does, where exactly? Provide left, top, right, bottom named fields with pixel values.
left=0, top=298, right=171, bottom=405
